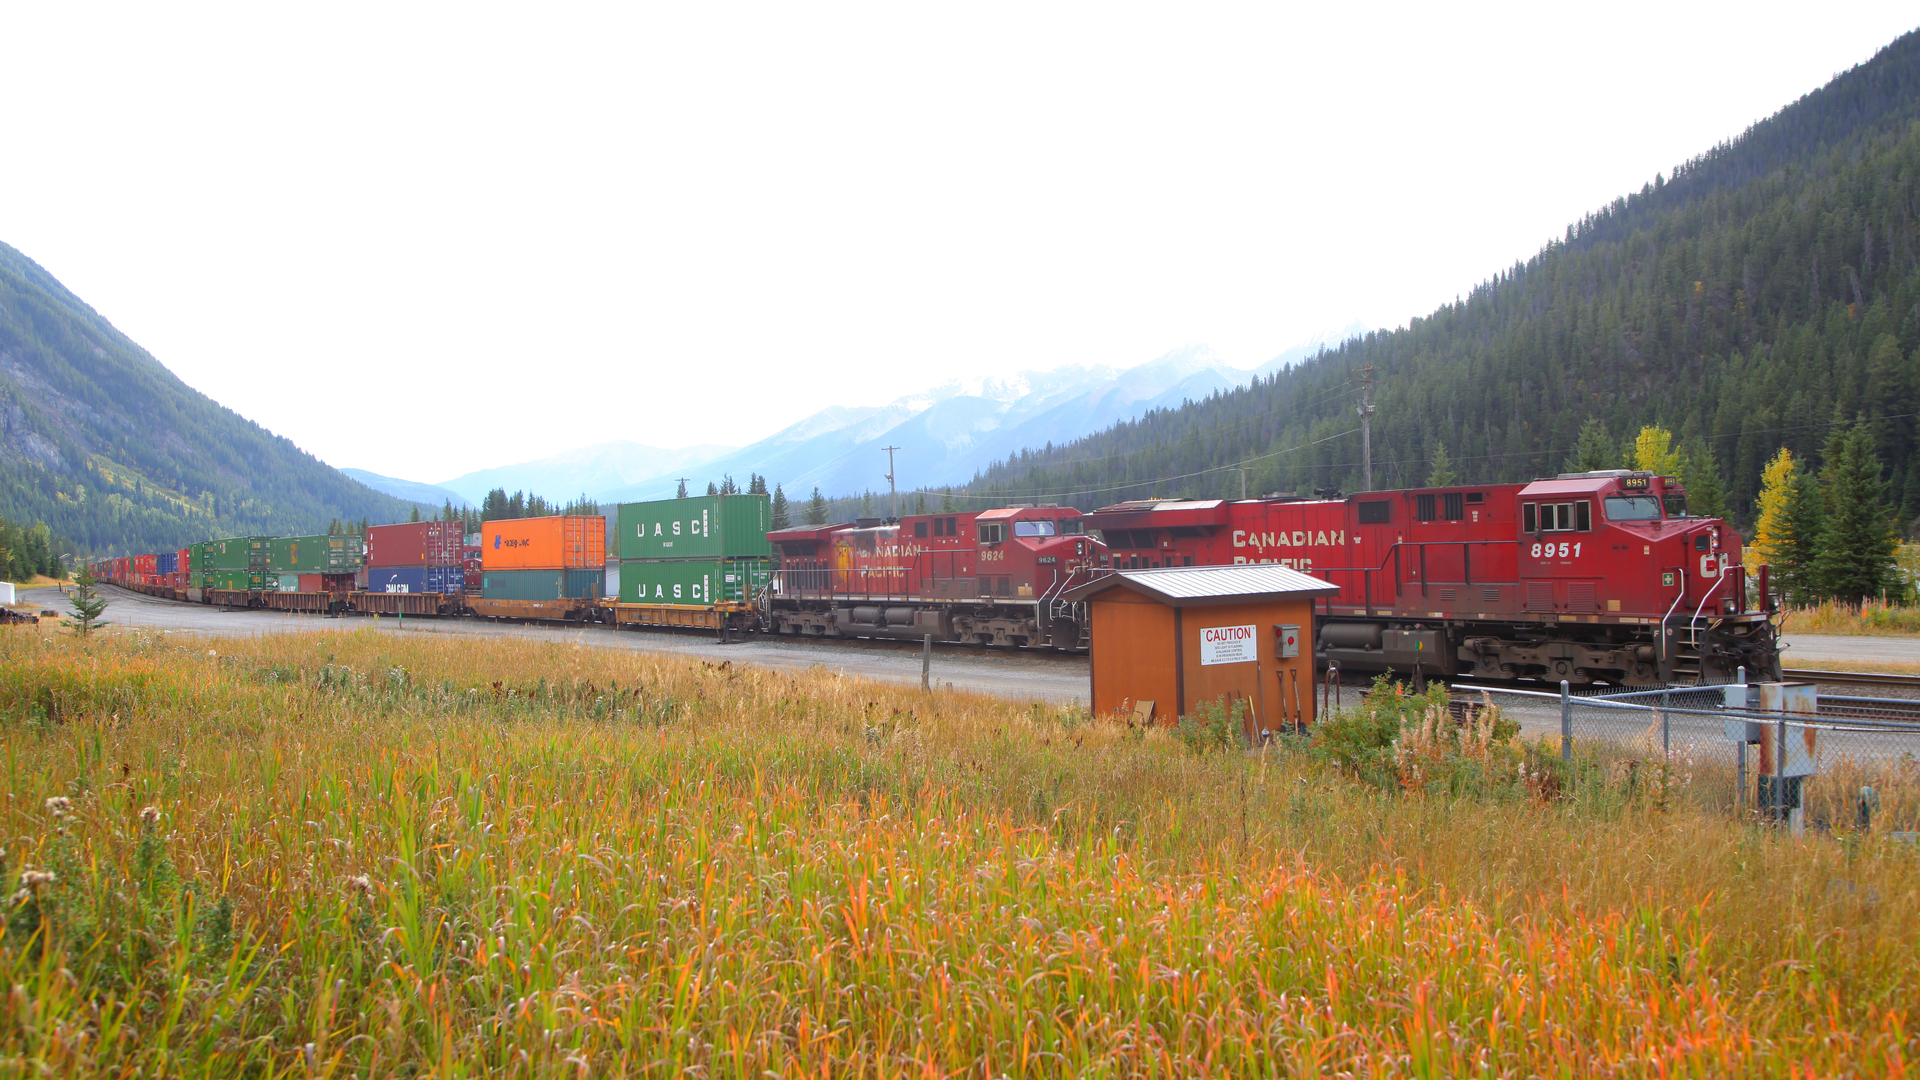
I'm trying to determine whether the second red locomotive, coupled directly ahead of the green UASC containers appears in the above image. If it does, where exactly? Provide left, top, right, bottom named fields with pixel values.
left=766, top=505, right=1106, bottom=650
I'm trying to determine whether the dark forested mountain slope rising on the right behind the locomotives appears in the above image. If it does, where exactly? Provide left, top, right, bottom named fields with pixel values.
left=968, top=26, right=1920, bottom=519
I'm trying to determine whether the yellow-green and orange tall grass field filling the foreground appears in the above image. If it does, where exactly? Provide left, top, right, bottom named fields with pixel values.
left=0, top=628, right=1920, bottom=1078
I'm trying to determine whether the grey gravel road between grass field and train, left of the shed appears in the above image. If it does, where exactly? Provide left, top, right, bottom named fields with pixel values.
left=21, top=586, right=1089, bottom=703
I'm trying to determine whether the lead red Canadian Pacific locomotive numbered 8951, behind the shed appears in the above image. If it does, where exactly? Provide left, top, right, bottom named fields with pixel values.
left=1087, top=471, right=1780, bottom=686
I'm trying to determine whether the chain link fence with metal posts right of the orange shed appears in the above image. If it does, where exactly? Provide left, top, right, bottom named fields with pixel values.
left=1452, top=684, right=1920, bottom=832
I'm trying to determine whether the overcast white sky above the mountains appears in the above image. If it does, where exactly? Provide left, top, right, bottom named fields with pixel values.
left=0, top=2, right=1920, bottom=480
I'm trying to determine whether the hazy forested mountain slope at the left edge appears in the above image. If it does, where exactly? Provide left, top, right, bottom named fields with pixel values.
left=0, top=244, right=413, bottom=553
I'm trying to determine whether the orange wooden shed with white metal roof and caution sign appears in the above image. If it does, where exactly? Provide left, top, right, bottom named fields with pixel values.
left=1062, top=563, right=1340, bottom=736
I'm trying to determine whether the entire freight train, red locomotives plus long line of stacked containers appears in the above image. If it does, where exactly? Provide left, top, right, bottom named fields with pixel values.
left=78, top=471, right=1780, bottom=684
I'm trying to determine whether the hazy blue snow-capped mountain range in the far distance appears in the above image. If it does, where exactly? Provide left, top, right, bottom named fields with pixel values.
left=346, top=323, right=1365, bottom=503
